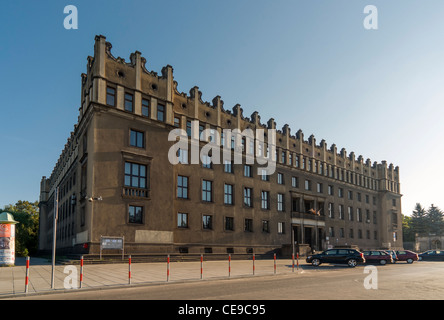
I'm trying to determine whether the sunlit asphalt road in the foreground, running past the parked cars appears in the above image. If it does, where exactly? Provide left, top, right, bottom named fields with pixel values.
left=7, top=261, right=444, bottom=301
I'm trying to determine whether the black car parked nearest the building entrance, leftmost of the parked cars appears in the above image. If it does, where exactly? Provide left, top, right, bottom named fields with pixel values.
left=306, top=249, right=365, bottom=268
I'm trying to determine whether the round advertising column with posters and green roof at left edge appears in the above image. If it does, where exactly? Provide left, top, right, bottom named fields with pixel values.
left=0, top=211, right=18, bottom=267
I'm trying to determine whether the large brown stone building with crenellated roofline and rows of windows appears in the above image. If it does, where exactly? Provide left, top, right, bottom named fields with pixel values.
left=39, top=36, right=402, bottom=253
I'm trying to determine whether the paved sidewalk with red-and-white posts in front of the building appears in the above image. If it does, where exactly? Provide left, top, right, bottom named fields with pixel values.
left=0, top=257, right=302, bottom=299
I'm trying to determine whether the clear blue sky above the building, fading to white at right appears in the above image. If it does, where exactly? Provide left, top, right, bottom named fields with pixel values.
left=0, top=0, right=444, bottom=215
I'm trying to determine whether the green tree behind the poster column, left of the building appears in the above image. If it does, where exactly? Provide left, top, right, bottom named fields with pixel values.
left=0, top=200, right=39, bottom=256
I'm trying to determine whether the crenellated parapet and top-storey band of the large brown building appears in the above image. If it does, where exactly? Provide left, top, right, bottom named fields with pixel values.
left=71, top=35, right=399, bottom=191
